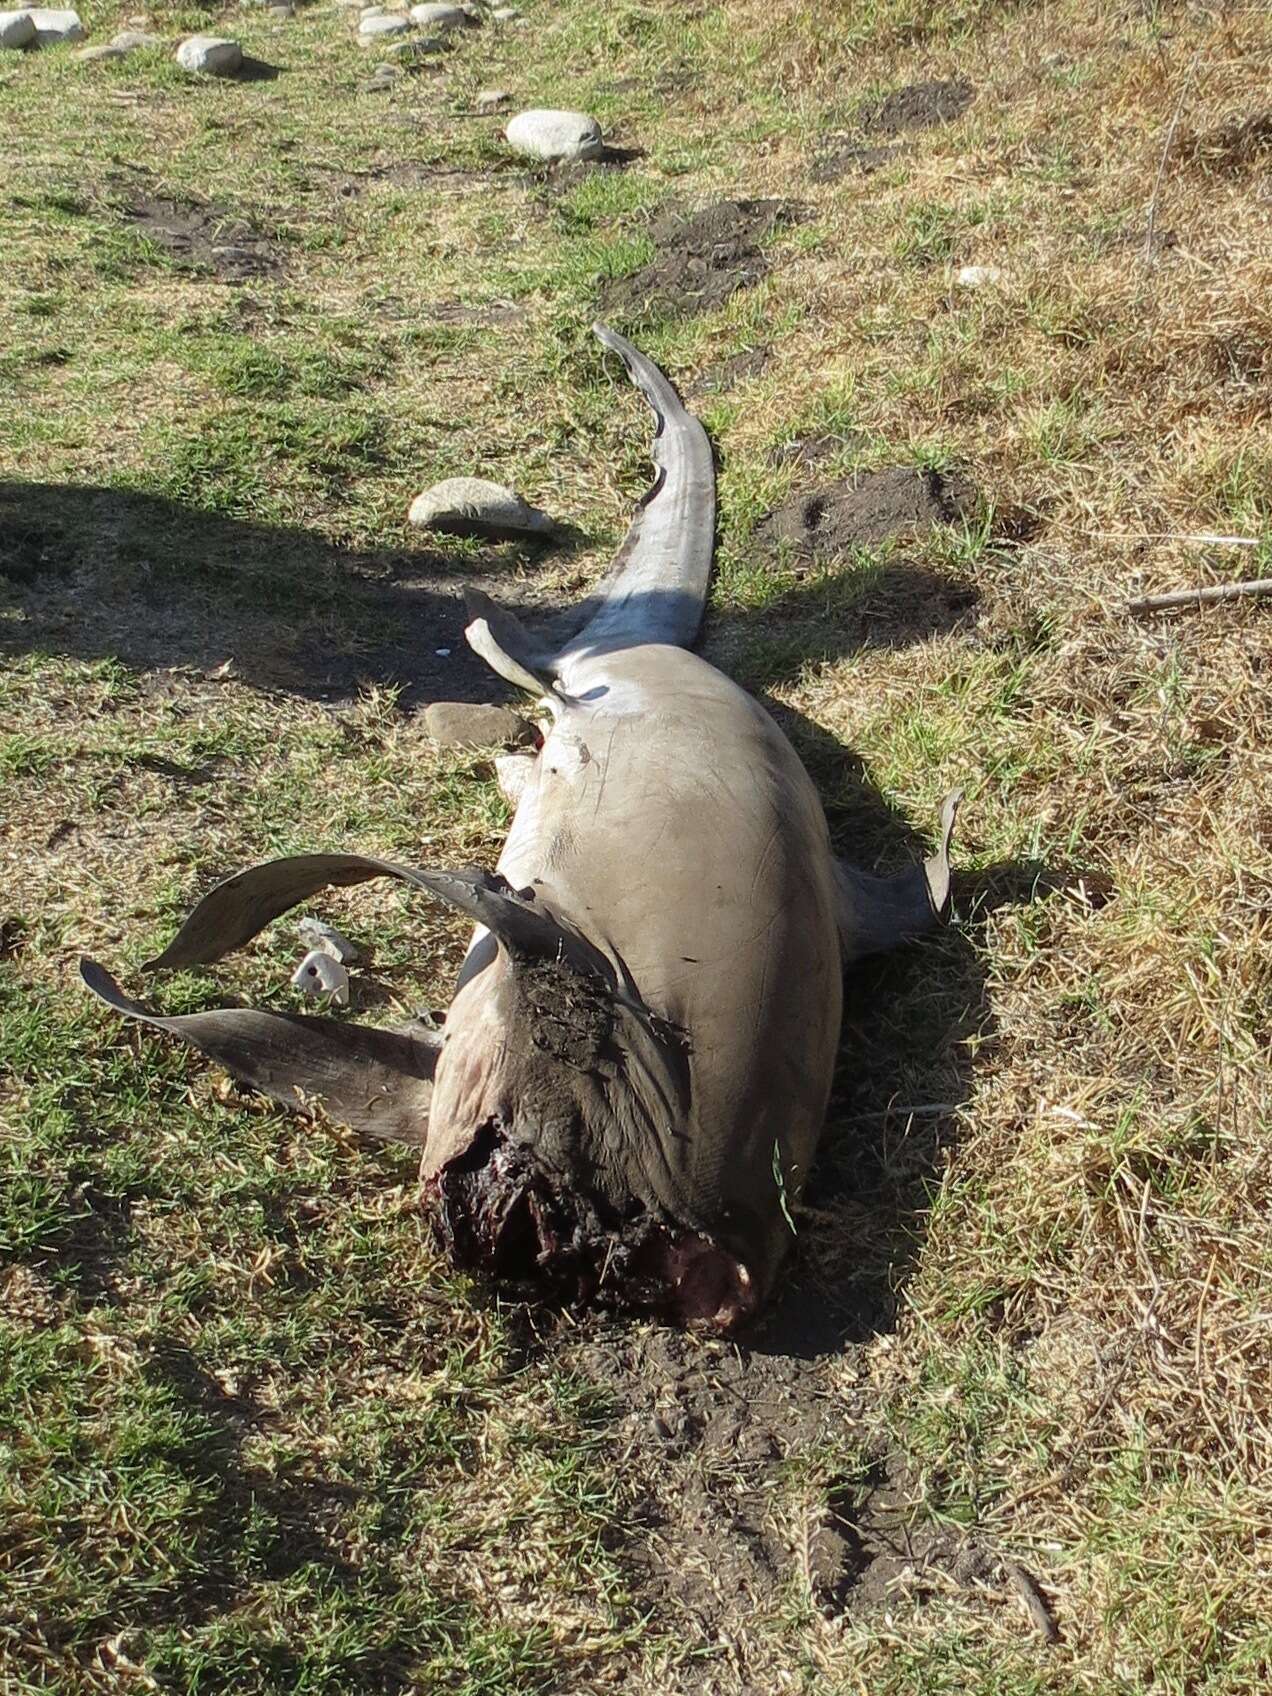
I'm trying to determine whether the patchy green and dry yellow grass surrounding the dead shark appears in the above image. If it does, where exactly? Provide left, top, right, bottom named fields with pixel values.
left=0, top=0, right=1272, bottom=1696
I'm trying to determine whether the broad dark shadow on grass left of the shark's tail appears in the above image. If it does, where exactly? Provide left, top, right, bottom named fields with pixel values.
left=0, top=482, right=556, bottom=707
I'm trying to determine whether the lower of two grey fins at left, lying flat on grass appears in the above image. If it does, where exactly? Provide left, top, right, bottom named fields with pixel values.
left=80, top=958, right=441, bottom=1146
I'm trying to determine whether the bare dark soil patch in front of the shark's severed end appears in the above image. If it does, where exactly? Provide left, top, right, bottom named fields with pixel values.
left=550, top=1321, right=1001, bottom=1691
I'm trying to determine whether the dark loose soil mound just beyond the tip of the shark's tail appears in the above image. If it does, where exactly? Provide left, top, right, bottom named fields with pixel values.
left=600, top=200, right=802, bottom=317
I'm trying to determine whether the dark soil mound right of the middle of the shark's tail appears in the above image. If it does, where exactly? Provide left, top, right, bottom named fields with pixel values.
left=755, top=466, right=974, bottom=563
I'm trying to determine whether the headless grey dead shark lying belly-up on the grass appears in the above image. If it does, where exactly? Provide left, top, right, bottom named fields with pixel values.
left=81, top=324, right=958, bottom=1331
